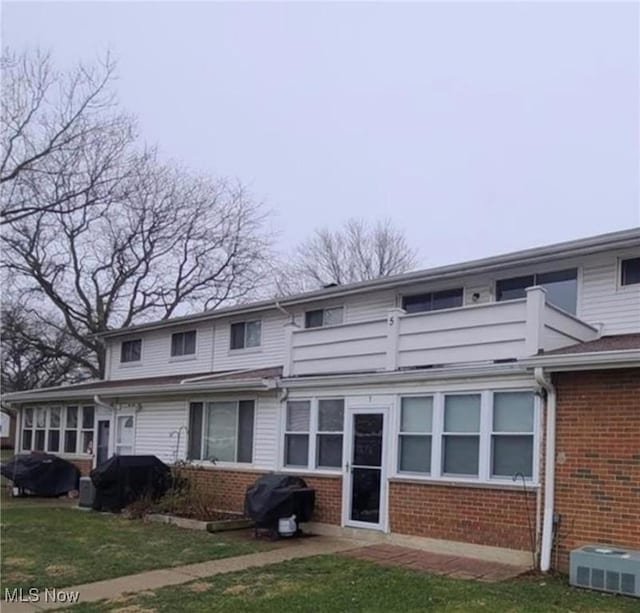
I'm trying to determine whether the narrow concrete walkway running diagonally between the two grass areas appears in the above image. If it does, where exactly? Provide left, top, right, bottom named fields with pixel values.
left=1, top=536, right=363, bottom=613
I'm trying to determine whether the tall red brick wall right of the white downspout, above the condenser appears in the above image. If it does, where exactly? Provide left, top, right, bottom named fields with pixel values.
left=553, top=368, right=640, bottom=571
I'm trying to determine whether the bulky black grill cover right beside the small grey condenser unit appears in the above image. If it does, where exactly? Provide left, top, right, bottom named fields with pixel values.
left=90, top=455, right=171, bottom=512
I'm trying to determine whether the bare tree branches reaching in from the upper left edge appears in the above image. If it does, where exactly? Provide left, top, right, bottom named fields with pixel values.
left=0, top=49, right=135, bottom=224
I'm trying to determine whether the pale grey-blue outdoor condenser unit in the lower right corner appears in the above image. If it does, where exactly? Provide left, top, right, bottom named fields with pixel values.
left=569, top=545, right=640, bottom=598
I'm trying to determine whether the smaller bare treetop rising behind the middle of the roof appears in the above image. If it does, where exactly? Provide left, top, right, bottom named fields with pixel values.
left=276, top=219, right=416, bottom=295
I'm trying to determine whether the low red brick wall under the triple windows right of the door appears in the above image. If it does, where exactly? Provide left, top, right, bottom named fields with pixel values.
left=389, top=481, right=536, bottom=551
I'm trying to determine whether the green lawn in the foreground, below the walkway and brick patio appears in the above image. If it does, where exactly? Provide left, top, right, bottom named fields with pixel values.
left=63, top=555, right=640, bottom=613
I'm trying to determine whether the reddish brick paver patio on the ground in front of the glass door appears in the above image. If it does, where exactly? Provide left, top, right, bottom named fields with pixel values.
left=342, top=544, right=529, bottom=581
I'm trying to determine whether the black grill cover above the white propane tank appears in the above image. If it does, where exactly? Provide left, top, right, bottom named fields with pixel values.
left=244, top=473, right=316, bottom=528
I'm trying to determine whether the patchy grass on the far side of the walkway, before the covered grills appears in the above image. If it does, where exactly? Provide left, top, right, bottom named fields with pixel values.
left=0, top=506, right=270, bottom=593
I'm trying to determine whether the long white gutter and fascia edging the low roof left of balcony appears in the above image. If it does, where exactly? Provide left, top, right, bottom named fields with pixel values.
left=3, top=379, right=272, bottom=404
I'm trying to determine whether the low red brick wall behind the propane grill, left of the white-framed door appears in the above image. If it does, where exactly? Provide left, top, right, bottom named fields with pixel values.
left=185, top=468, right=342, bottom=524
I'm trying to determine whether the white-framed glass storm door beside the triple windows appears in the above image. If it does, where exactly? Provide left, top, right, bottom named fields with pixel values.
left=342, top=408, right=388, bottom=530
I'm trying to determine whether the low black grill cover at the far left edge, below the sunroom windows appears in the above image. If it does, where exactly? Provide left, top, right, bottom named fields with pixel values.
left=0, top=453, right=80, bottom=496
